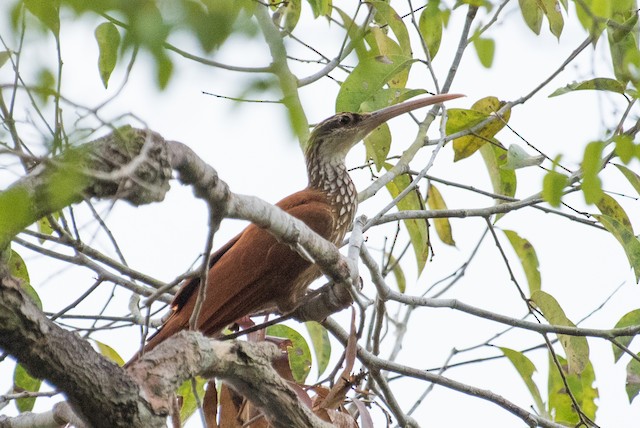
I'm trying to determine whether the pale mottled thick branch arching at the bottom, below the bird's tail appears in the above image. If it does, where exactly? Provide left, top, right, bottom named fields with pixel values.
left=128, top=331, right=330, bottom=428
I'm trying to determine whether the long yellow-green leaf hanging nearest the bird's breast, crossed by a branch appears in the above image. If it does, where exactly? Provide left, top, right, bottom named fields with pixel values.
left=385, top=164, right=429, bottom=274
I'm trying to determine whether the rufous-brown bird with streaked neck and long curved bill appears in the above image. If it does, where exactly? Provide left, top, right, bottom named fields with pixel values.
left=143, top=94, right=462, bottom=352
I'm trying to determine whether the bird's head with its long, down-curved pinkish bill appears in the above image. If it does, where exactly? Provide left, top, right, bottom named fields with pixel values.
left=305, top=94, right=463, bottom=164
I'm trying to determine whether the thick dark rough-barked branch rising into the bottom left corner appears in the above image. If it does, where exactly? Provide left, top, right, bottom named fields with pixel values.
left=0, top=266, right=160, bottom=427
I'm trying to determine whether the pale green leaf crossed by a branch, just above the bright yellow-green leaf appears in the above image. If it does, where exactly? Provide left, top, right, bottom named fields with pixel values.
left=531, top=290, right=589, bottom=374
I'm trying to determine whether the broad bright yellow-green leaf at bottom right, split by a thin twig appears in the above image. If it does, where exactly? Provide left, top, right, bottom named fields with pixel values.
left=548, top=353, right=598, bottom=426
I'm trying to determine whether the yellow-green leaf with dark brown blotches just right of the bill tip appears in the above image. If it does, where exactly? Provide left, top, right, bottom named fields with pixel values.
left=447, top=97, right=511, bottom=162
